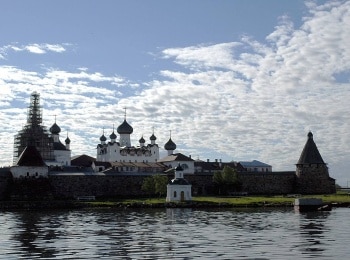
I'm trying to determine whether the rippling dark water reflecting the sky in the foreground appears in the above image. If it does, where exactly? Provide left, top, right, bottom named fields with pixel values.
left=0, top=208, right=350, bottom=259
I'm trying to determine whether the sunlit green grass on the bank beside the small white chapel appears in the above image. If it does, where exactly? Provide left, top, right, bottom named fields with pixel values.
left=85, top=192, right=350, bottom=207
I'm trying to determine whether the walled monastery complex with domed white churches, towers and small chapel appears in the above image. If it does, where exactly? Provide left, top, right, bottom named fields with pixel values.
left=0, top=92, right=335, bottom=201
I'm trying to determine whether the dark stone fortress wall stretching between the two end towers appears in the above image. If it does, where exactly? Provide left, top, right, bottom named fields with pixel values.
left=49, top=172, right=295, bottom=198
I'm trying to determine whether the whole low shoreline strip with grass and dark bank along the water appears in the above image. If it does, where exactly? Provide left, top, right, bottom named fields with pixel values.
left=0, top=192, right=350, bottom=210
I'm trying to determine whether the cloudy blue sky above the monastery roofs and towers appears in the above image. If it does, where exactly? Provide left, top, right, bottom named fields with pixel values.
left=0, top=0, right=350, bottom=186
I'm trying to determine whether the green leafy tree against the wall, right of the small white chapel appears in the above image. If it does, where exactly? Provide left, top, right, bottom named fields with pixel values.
left=213, top=166, right=241, bottom=194
